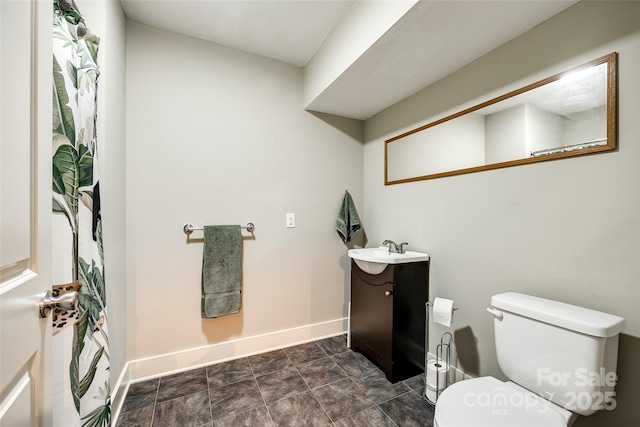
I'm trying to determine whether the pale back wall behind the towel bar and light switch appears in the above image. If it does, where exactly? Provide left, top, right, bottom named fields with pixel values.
left=126, top=21, right=363, bottom=373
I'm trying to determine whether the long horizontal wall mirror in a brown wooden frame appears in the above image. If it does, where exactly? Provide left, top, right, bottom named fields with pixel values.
left=385, top=53, right=617, bottom=185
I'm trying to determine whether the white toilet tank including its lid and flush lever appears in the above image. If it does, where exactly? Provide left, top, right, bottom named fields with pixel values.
left=488, top=292, right=624, bottom=415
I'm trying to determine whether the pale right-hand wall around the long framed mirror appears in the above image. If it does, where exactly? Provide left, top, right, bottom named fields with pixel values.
left=365, top=1, right=640, bottom=425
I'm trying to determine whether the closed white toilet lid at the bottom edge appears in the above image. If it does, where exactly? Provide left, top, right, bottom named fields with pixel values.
left=434, top=377, right=568, bottom=427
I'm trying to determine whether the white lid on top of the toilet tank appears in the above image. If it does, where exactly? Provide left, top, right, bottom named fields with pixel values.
left=491, top=292, right=625, bottom=337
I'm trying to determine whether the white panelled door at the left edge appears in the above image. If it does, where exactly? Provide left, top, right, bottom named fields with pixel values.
left=0, top=0, right=53, bottom=427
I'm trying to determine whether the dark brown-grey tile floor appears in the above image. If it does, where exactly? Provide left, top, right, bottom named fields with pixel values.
left=117, top=337, right=433, bottom=427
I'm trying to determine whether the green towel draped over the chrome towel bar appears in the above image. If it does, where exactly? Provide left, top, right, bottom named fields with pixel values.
left=200, top=225, right=242, bottom=318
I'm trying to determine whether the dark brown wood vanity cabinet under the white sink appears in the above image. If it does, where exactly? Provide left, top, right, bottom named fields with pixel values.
left=350, top=260, right=429, bottom=383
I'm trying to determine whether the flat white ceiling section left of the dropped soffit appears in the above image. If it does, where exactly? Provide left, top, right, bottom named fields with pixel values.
left=121, top=0, right=353, bottom=67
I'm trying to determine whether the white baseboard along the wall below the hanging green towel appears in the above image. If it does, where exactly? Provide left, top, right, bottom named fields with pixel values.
left=111, top=318, right=347, bottom=425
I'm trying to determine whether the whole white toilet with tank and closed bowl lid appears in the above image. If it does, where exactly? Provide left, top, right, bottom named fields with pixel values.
left=434, top=292, right=624, bottom=427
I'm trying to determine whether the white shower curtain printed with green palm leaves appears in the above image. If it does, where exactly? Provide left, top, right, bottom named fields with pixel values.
left=53, top=0, right=111, bottom=427
